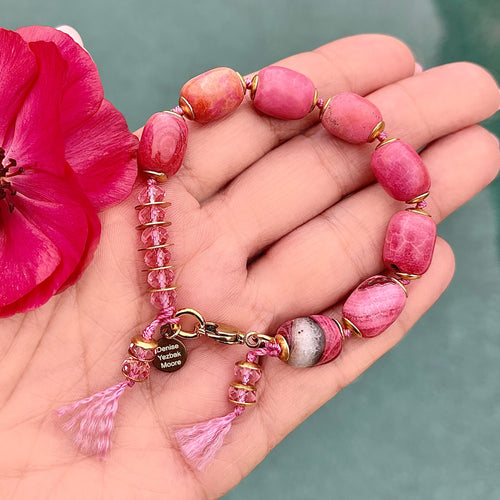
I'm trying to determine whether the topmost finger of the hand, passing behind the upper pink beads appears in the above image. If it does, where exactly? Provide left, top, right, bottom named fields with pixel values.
left=174, top=35, right=415, bottom=201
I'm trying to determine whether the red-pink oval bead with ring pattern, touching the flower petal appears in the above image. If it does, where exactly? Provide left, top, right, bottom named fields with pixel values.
left=137, top=112, right=188, bottom=177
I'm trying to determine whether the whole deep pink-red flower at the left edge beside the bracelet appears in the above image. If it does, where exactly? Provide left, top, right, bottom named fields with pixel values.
left=0, top=26, right=137, bottom=316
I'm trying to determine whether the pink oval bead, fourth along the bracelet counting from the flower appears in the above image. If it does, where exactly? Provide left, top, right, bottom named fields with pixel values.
left=321, top=92, right=382, bottom=144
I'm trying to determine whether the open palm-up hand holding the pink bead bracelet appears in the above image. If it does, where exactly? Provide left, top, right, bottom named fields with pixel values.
left=0, top=35, right=499, bottom=499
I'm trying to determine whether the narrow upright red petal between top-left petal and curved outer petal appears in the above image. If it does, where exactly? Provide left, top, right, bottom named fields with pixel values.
left=6, top=42, right=67, bottom=175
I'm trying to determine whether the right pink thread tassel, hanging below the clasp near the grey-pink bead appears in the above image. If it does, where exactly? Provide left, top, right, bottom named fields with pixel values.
left=175, top=406, right=245, bottom=470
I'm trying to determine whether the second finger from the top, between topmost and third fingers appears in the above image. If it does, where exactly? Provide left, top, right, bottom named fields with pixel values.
left=206, top=63, right=499, bottom=257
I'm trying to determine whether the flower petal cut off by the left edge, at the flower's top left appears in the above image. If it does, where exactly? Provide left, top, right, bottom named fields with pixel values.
left=0, top=28, right=38, bottom=140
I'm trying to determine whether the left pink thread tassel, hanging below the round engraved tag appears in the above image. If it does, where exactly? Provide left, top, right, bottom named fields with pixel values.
left=57, top=380, right=134, bottom=457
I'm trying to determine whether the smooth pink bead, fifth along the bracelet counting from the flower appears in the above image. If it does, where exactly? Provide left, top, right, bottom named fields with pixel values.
left=371, top=140, right=431, bottom=201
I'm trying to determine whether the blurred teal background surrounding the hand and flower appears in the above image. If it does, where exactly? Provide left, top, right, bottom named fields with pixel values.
left=0, top=0, right=500, bottom=500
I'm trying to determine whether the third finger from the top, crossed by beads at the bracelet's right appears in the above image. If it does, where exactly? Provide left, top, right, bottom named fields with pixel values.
left=247, top=126, right=500, bottom=321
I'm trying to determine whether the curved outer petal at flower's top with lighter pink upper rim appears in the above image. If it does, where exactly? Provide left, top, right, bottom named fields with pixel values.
left=17, top=26, right=104, bottom=133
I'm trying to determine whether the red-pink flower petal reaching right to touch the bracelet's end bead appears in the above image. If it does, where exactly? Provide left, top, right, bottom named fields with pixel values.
left=65, top=100, right=138, bottom=211
